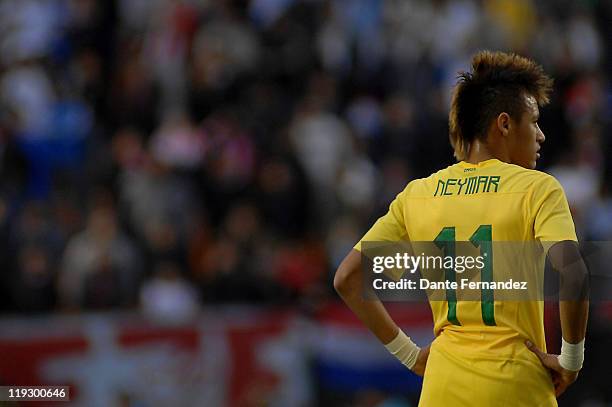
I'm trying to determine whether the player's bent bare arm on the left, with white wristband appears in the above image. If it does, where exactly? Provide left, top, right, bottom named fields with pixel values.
left=334, top=249, right=429, bottom=376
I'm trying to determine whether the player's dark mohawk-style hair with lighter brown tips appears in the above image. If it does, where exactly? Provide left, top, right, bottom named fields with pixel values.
left=449, top=51, right=553, bottom=160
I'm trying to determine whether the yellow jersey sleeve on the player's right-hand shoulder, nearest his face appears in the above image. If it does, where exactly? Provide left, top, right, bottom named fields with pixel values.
left=532, top=176, right=578, bottom=245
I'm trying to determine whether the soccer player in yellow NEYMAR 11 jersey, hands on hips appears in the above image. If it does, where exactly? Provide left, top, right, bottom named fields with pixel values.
left=334, top=51, right=588, bottom=407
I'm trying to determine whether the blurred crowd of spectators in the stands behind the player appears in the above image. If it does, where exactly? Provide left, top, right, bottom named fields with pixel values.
left=0, top=0, right=612, bottom=320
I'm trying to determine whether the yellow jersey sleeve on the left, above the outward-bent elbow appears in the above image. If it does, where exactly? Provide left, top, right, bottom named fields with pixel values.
left=354, top=187, right=408, bottom=251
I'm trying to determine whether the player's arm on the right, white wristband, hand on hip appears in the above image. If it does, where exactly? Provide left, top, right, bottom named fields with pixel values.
left=527, top=241, right=589, bottom=397
